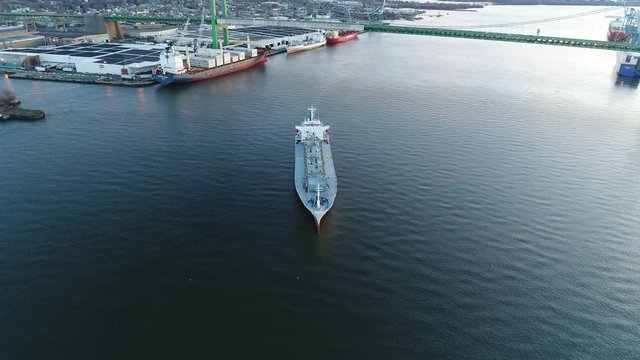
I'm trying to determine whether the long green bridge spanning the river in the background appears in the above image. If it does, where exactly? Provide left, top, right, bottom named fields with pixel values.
left=0, top=13, right=640, bottom=51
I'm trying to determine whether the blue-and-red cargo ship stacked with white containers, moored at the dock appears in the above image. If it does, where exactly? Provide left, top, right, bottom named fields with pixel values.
left=152, top=46, right=267, bottom=85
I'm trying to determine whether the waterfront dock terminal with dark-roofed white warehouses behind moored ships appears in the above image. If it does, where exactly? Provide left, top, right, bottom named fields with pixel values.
left=0, top=24, right=338, bottom=87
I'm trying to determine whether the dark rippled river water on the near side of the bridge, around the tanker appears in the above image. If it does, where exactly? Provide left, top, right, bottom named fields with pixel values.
left=0, top=13, right=640, bottom=359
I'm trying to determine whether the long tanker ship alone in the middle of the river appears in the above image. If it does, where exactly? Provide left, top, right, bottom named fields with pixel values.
left=294, top=106, right=338, bottom=232
